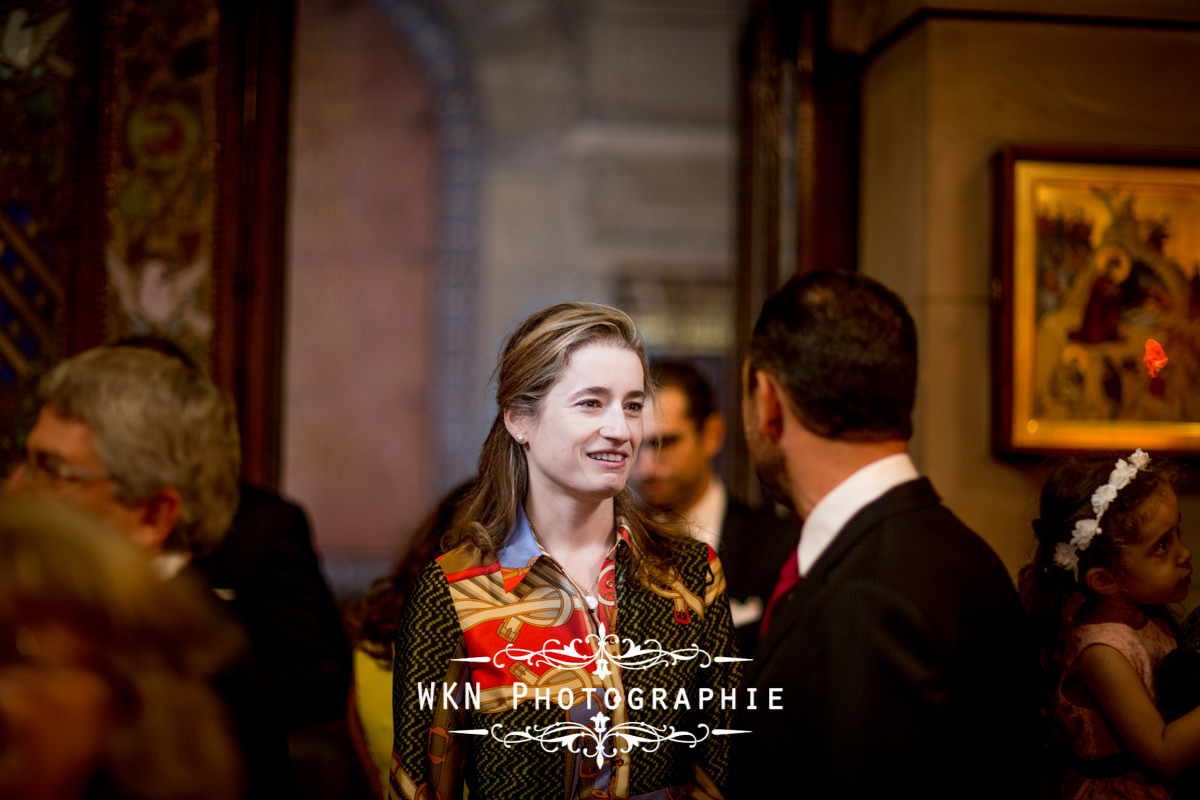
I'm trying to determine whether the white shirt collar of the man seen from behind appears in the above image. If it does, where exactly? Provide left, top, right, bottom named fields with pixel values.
left=797, top=453, right=920, bottom=576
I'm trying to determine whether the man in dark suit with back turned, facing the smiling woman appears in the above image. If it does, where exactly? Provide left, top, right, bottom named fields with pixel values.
left=731, top=272, right=1037, bottom=798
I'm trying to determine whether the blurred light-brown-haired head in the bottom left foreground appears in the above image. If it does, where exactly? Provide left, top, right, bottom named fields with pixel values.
left=0, top=498, right=244, bottom=798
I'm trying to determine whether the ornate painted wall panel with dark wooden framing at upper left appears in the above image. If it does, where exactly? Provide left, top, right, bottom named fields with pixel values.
left=0, top=0, right=293, bottom=485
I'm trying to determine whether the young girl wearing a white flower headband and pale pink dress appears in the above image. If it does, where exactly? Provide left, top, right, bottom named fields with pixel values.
left=1019, top=450, right=1200, bottom=798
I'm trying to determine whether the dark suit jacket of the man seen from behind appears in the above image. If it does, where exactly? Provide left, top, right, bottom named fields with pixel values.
left=731, top=480, right=1037, bottom=799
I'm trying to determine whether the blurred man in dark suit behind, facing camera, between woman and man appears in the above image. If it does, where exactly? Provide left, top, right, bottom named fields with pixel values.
left=634, top=361, right=799, bottom=654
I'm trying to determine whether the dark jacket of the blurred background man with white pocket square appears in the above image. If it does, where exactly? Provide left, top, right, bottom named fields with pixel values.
left=718, top=498, right=800, bottom=655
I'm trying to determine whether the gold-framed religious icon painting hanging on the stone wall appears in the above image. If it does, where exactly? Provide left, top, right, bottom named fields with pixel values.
left=992, top=146, right=1200, bottom=455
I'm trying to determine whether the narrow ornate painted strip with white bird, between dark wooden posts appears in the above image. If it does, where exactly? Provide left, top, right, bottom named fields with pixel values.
left=104, top=0, right=220, bottom=362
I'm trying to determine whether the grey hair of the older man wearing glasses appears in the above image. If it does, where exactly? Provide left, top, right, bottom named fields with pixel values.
left=37, top=345, right=241, bottom=555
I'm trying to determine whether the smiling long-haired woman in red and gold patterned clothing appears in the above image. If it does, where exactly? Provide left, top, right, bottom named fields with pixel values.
left=391, top=302, right=737, bottom=800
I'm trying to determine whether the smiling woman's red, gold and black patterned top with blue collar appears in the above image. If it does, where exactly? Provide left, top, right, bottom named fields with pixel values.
left=389, top=515, right=739, bottom=800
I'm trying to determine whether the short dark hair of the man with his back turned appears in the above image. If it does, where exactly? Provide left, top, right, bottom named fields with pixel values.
left=750, top=271, right=917, bottom=441
